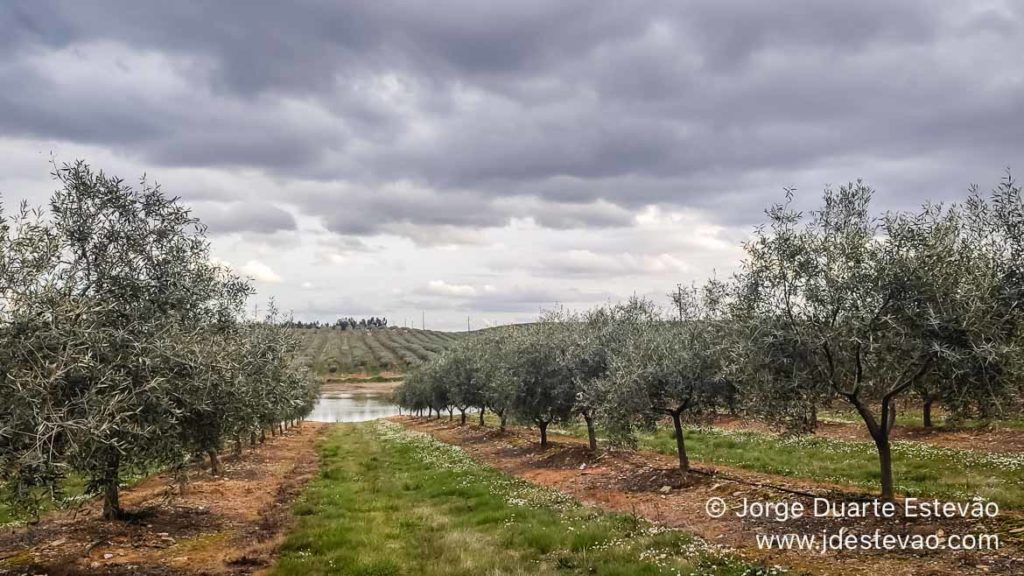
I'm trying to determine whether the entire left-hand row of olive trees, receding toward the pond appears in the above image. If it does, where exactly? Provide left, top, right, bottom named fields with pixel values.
left=0, top=162, right=316, bottom=518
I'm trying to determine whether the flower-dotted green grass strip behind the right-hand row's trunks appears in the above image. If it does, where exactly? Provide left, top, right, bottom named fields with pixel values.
left=544, top=416, right=1024, bottom=508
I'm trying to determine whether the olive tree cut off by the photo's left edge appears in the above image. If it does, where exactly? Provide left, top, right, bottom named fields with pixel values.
left=0, top=200, right=68, bottom=508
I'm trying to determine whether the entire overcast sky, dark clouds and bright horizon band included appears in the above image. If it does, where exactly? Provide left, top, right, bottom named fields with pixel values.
left=0, top=0, right=1024, bottom=329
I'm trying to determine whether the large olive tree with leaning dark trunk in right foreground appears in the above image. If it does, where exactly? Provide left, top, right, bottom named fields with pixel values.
left=734, top=181, right=1015, bottom=498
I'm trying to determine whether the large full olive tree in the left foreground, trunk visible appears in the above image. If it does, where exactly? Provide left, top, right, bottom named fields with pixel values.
left=0, top=162, right=231, bottom=518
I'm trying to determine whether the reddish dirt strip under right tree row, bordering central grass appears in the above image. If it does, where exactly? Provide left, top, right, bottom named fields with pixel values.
left=395, top=417, right=1024, bottom=576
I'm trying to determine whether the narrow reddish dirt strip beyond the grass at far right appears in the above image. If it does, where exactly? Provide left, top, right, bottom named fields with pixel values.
left=714, top=416, right=1024, bottom=453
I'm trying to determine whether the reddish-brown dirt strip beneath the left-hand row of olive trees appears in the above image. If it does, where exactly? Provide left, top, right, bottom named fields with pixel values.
left=0, top=422, right=327, bottom=576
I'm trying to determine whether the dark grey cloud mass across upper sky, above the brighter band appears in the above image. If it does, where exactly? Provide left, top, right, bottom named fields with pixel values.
left=0, top=0, right=1024, bottom=236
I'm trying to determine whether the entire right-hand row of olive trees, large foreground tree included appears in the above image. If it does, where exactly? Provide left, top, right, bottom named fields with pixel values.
left=398, top=177, right=1024, bottom=498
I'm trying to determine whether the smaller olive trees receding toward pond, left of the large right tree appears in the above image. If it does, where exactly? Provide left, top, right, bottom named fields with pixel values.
left=396, top=292, right=732, bottom=461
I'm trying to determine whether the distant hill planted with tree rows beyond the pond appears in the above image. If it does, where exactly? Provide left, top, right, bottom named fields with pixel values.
left=293, top=328, right=466, bottom=375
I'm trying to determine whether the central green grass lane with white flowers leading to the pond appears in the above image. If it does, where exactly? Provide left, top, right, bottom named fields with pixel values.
left=273, top=421, right=768, bottom=576
